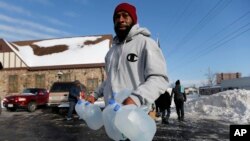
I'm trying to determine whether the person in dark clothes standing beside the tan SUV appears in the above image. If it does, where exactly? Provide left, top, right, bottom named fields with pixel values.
left=66, top=80, right=81, bottom=120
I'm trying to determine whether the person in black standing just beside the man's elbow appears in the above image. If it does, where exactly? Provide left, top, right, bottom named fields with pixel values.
left=155, top=91, right=171, bottom=124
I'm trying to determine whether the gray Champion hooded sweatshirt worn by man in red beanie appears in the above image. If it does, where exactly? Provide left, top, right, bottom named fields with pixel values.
left=94, top=24, right=168, bottom=106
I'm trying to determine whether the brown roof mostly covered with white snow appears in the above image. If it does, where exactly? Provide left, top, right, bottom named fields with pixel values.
left=4, top=35, right=112, bottom=67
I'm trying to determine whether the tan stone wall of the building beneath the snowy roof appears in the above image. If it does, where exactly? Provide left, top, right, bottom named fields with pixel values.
left=0, top=67, right=106, bottom=99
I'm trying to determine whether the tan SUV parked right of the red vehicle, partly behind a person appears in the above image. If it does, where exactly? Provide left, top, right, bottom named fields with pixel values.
left=48, top=82, right=87, bottom=108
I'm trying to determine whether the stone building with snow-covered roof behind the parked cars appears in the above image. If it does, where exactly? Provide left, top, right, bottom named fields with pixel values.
left=0, top=35, right=112, bottom=98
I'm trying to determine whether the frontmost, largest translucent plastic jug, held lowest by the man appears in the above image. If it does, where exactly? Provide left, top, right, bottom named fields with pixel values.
left=115, top=105, right=156, bottom=141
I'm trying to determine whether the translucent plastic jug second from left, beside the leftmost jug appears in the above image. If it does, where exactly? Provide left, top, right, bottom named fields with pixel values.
left=83, top=102, right=103, bottom=130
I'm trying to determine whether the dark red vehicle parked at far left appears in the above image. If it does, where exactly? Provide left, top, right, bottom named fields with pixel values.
left=3, top=88, right=49, bottom=112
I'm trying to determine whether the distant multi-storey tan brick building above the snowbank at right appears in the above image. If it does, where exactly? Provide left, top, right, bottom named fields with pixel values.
left=216, top=72, right=241, bottom=85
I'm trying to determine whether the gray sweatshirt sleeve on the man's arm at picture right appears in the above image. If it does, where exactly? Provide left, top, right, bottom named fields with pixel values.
left=132, top=40, right=168, bottom=104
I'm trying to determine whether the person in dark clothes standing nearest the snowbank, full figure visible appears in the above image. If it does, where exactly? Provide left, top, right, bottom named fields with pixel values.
left=171, top=80, right=187, bottom=121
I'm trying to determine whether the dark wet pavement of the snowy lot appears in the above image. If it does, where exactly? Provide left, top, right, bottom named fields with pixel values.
left=0, top=109, right=229, bottom=141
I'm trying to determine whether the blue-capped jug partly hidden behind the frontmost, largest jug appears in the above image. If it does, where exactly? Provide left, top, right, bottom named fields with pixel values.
left=102, top=99, right=126, bottom=141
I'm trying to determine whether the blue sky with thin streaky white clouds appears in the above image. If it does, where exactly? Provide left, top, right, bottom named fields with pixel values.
left=0, top=0, right=250, bottom=85
